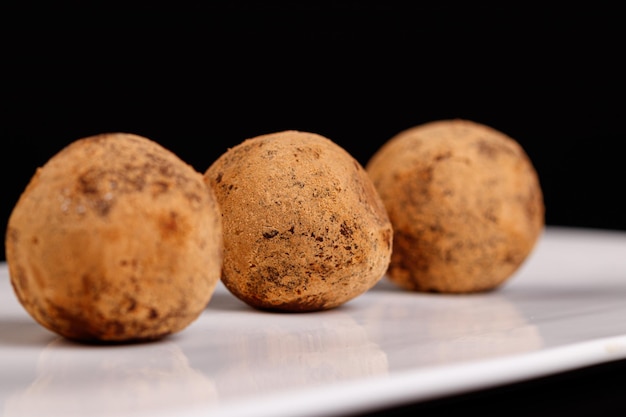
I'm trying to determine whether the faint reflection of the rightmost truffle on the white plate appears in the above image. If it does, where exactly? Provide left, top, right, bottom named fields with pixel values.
left=363, top=290, right=545, bottom=370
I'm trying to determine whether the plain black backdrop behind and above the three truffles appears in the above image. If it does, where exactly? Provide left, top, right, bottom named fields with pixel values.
left=0, top=1, right=626, bottom=257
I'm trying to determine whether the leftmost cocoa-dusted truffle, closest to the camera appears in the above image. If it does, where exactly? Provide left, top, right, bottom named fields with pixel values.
left=6, top=133, right=222, bottom=341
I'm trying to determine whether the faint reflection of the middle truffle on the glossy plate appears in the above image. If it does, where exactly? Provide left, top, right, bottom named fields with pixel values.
left=207, top=310, right=388, bottom=398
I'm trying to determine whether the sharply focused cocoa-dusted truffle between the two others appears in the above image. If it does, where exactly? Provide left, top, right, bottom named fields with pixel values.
left=205, top=131, right=392, bottom=311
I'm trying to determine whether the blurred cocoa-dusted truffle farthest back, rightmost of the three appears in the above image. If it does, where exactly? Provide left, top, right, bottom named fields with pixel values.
left=366, top=120, right=544, bottom=293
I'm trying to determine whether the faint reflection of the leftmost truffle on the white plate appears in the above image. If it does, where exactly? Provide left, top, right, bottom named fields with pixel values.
left=0, top=338, right=219, bottom=417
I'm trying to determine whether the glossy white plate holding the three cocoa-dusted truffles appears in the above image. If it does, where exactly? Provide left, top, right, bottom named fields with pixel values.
left=0, top=227, right=626, bottom=417
